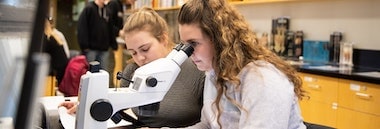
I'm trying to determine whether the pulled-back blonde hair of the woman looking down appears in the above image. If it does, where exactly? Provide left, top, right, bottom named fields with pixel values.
left=123, top=7, right=175, bottom=49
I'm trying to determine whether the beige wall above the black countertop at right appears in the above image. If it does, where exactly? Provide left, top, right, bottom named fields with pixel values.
left=236, top=0, right=380, bottom=50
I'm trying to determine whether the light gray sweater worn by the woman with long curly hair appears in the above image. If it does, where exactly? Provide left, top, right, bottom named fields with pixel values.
left=180, top=61, right=306, bottom=129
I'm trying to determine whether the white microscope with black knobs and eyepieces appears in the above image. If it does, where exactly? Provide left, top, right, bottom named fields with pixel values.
left=75, top=44, right=194, bottom=129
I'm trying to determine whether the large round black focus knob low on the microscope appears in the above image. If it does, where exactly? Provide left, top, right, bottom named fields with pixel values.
left=90, top=99, right=113, bottom=121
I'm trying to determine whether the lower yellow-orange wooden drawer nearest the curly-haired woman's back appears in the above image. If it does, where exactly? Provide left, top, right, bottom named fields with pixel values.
left=300, top=99, right=337, bottom=128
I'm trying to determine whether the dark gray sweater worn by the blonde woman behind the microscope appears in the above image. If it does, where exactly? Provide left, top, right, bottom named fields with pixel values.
left=121, top=59, right=205, bottom=128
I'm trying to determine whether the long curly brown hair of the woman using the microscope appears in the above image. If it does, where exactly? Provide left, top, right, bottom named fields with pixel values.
left=178, top=0, right=305, bottom=126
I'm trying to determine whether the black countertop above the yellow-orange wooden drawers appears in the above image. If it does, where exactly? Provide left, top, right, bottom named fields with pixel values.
left=289, top=61, right=380, bottom=84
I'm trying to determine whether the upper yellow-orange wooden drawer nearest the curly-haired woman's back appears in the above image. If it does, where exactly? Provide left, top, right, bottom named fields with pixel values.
left=300, top=73, right=339, bottom=103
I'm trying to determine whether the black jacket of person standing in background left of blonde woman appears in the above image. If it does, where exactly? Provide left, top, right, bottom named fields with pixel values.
left=78, top=2, right=117, bottom=51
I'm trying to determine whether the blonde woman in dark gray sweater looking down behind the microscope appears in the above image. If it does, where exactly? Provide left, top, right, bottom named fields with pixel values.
left=61, top=8, right=205, bottom=128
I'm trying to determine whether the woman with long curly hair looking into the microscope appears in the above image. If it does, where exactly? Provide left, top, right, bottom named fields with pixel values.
left=151, top=0, right=306, bottom=129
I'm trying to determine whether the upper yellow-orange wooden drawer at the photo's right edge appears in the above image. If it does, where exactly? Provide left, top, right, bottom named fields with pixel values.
left=338, top=79, right=380, bottom=116
